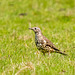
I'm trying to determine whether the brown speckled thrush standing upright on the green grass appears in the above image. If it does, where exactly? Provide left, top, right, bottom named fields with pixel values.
left=29, top=27, right=67, bottom=55
